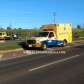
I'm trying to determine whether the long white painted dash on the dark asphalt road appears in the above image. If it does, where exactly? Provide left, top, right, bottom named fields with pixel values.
left=29, top=54, right=80, bottom=72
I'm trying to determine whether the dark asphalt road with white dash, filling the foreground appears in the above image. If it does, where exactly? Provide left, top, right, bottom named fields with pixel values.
left=0, top=44, right=84, bottom=84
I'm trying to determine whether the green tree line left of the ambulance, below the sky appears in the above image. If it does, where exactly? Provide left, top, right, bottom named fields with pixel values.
left=0, top=27, right=40, bottom=38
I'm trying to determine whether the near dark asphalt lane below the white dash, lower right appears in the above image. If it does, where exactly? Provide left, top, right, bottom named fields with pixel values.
left=6, top=52, right=84, bottom=84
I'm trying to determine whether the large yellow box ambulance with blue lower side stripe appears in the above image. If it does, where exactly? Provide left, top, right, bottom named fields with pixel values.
left=27, top=24, right=72, bottom=49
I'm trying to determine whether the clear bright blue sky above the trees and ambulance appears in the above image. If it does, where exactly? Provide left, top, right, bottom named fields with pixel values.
left=0, top=0, right=84, bottom=28
